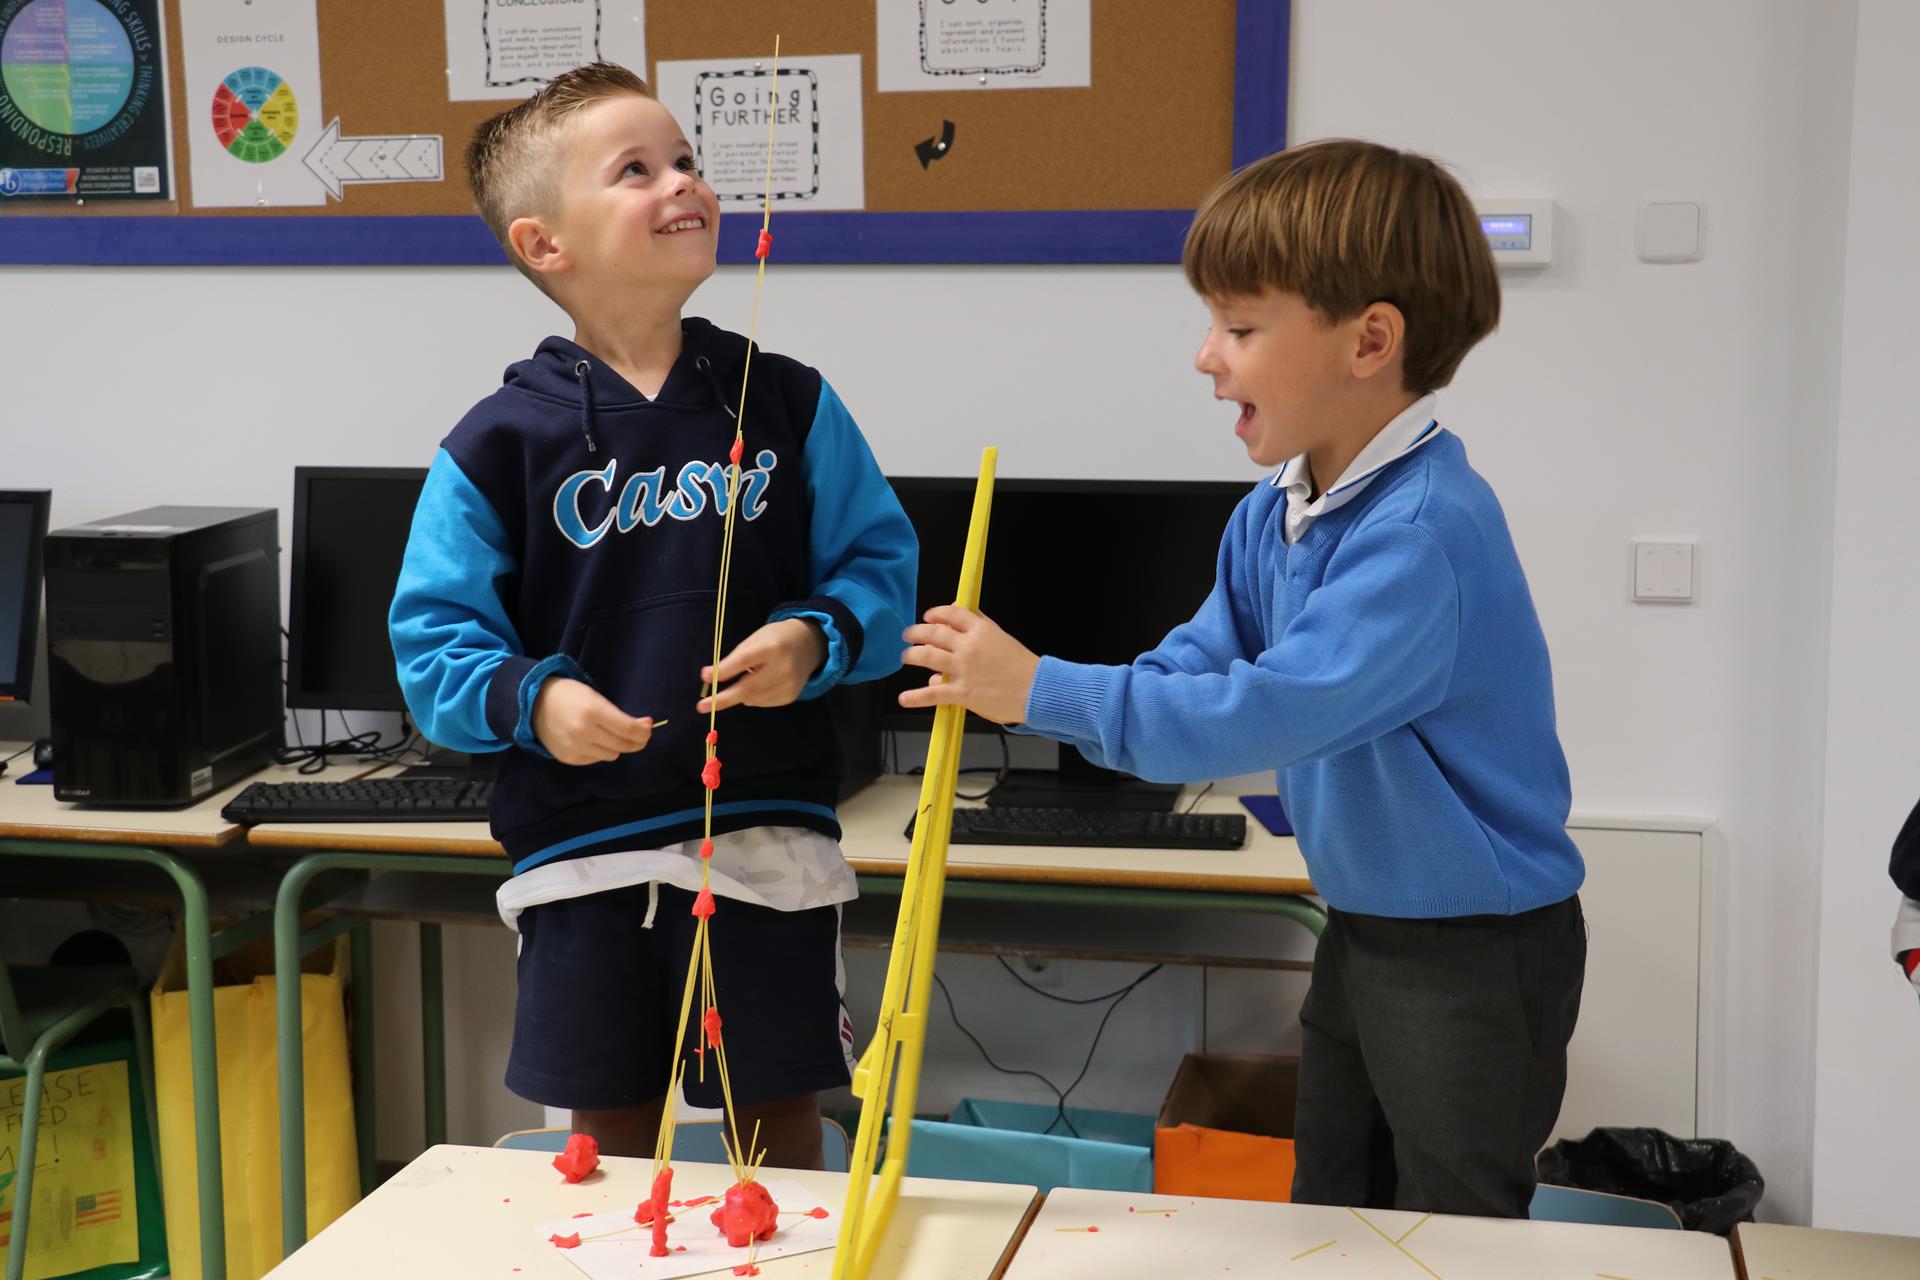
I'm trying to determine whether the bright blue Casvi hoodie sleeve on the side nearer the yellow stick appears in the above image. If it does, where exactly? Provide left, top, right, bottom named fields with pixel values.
left=770, top=378, right=920, bottom=699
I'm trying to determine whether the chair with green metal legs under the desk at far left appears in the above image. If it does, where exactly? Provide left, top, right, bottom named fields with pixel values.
left=0, top=965, right=159, bottom=1280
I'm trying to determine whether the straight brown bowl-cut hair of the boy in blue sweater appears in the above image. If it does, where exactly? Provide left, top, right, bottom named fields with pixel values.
left=1181, top=138, right=1500, bottom=395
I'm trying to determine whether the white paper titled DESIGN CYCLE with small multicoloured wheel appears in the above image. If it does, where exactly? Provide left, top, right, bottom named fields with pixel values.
left=180, top=0, right=326, bottom=209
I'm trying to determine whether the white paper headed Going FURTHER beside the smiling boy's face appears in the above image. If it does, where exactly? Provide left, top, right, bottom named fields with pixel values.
left=655, top=54, right=866, bottom=209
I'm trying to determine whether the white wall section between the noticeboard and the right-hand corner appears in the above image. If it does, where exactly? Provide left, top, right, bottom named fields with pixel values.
left=1292, top=0, right=1853, bottom=1219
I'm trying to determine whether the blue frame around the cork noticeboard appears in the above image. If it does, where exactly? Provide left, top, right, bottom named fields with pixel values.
left=0, top=0, right=1292, bottom=267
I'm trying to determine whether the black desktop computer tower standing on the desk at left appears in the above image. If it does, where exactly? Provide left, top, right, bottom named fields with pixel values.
left=46, top=507, right=284, bottom=806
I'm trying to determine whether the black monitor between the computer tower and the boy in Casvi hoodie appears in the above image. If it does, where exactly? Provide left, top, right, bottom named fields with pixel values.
left=286, top=466, right=426, bottom=712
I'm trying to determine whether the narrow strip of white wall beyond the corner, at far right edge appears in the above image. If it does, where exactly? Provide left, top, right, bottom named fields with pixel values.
left=1812, top=0, right=1920, bottom=1234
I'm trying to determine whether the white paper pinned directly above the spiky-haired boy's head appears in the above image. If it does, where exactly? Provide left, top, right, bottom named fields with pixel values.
left=445, top=0, right=647, bottom=102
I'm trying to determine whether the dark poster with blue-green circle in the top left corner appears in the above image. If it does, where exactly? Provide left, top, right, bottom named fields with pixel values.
left=0, top=0, right=173, bottom=205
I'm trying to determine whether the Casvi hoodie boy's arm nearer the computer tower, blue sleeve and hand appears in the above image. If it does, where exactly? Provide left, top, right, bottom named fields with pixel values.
left=388, top=451, right=653, bottom=764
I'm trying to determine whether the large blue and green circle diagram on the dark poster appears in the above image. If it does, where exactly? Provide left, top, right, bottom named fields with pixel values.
left=0, top=0, right=134, bottom=136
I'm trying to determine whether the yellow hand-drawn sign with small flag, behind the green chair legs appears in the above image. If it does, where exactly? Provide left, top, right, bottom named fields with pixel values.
left=0, top=1061, right=140, bottom=1280
